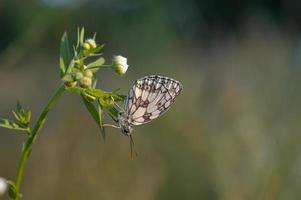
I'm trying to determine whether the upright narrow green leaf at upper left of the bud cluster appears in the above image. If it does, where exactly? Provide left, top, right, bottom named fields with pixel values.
left=60, top=32, right=72, bottom=77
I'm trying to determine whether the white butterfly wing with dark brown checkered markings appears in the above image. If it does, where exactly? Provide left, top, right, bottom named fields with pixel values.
left=124, top=75, right=182, bottom=125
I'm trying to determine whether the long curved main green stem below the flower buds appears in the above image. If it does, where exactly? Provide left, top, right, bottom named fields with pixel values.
left=15, top=85, right=65, bottom=200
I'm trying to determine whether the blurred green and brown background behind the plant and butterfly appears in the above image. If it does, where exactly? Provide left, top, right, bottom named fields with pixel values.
left=0, top=0, right=301, bottom=200
